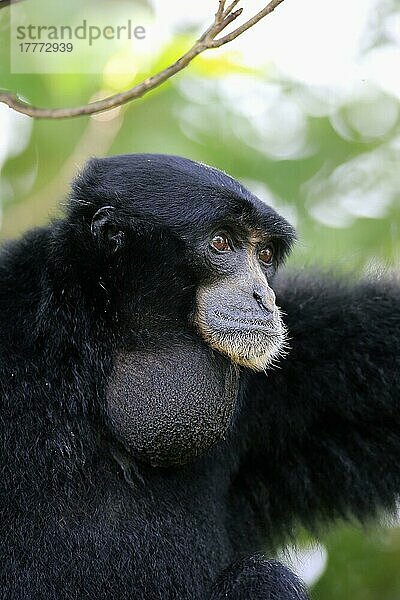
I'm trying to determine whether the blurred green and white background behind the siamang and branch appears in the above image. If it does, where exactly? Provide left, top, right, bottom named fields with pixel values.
left=0, top=0, right=400, bottom=600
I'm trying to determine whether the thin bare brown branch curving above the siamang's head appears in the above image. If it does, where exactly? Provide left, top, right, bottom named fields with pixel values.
left=0, top=0, right=283, bottom=119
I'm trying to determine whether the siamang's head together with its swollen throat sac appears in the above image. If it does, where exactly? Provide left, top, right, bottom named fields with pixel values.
left=72, top=155, right=294, bottom=466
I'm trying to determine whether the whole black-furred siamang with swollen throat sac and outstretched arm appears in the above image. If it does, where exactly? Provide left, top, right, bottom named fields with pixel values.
left=0, top=154, right=400, bottom=600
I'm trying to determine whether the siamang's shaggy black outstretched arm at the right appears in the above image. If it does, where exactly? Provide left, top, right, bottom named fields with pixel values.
left=236, top=276, right=400, bottom=531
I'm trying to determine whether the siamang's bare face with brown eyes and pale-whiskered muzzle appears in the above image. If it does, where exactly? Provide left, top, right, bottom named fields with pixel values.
left=195, top=223, right=286, bottom=371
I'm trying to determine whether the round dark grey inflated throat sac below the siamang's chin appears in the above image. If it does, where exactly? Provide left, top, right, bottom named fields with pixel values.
left=107, top=342, right=238, bottom=467
